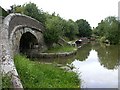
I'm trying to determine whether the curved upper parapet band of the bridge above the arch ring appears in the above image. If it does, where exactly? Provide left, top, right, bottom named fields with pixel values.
left=3, top=13, right=45, bottom=37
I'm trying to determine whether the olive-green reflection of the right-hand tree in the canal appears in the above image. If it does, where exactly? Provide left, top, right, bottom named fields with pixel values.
left=96, top=45, right=120, bottom=69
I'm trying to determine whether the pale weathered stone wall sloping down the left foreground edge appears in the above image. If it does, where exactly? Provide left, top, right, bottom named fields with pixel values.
left=0, top=20, right=22, bottom=88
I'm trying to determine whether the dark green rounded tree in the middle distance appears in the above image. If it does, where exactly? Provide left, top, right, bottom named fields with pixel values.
left=76, top=19, right=92, bottom=37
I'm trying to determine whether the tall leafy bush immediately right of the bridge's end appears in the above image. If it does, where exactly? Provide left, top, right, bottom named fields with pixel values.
left=44, top=16, right=63, bottom=45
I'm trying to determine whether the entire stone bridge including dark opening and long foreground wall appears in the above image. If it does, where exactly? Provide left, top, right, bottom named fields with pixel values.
left=0, top=14, right=46, bottom=88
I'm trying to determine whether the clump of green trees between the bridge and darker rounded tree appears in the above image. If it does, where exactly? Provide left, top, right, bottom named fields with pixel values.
left=44, top=13, right=78, bottom=45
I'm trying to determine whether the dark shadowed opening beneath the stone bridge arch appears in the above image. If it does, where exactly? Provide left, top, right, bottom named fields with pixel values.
left=19, top=32, right=38, bottom=53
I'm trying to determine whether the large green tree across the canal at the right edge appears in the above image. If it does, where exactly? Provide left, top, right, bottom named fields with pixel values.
left=94, top=16, right=120, bottom=44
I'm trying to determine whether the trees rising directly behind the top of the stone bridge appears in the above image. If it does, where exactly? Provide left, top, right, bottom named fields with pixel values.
left=8, top=2, right=46, bottom=24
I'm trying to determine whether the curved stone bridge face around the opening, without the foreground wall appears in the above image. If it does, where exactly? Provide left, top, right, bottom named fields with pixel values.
left=4, top=13, right=46, bottom=54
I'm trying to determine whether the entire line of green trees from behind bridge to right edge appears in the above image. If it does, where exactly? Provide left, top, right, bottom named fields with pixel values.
left=2, top=2, right=120, bottom=45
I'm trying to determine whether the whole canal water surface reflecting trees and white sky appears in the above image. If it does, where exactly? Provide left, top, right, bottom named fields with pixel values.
left=38, top=42, right=120, bottom=88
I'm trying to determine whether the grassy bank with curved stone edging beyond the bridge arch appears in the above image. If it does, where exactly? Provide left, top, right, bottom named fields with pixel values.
left=27, top=41, right=88, bottom=59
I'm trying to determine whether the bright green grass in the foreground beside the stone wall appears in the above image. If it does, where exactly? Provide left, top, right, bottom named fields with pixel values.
left=14, top=55, right=80, bottom=88
